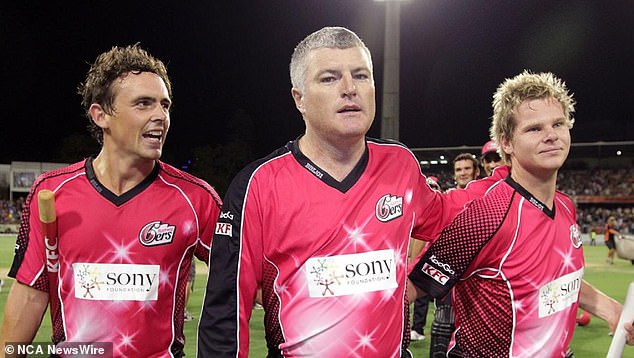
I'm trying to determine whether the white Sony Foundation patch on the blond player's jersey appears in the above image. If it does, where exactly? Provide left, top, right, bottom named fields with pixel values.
left=539, top=269, right=583, bottom=318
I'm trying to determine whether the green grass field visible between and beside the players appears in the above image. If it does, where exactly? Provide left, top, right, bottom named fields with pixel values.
left=0, top=236, right=634, bottom=358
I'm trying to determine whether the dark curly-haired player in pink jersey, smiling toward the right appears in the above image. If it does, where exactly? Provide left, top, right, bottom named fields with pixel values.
left=0, top=45, right=221, bottom=357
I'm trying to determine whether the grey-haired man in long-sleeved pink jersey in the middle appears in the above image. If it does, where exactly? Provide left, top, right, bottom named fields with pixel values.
left=198, top=27, right=508, bottom=358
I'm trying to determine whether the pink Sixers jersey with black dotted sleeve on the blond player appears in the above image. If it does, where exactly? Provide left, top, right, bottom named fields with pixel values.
left=410, top=176, right=584, bottom=358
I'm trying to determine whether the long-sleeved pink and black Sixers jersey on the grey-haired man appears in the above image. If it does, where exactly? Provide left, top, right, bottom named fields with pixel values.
left=198, top=140, right=504, bottom=358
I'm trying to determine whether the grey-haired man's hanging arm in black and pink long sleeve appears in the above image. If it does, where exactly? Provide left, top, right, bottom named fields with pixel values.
left=197, top=169, right=261, bottom=358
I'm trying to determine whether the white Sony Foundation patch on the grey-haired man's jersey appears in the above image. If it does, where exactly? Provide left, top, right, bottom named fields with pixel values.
left=304, top=250, right=398, bottom=297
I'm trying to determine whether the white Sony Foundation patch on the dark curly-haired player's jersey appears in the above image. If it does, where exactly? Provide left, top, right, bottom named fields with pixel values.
left=73, top=263, right=160, bottom=301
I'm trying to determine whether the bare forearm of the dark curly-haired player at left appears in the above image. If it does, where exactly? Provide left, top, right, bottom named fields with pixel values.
left=2, top=281, right=48, bottom=346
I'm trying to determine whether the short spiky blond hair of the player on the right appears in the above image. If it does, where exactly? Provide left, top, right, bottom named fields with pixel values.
left=489, top=70, right=575, bottom=163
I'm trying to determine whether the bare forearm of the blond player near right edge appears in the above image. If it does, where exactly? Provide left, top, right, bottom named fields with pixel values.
left=579, top=280, right=631, bottom=332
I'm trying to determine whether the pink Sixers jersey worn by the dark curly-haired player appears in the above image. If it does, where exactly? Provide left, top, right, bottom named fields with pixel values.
left=10, top=159, right=220, bottom=357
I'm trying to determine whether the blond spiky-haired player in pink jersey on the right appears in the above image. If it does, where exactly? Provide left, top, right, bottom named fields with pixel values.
left=408, top=71, right=632, bottom=357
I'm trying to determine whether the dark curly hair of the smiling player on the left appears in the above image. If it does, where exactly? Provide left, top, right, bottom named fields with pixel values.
left=77, top=43, right=172, bottom=144
